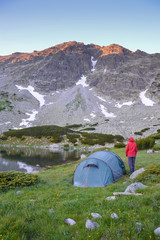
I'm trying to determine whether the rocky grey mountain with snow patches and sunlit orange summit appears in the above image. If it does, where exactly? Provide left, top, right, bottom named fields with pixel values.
left=0, top=42, right=160, bottom=137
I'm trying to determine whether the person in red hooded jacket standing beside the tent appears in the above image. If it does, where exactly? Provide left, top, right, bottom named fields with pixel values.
left=126, top=137, right=138, bottom=174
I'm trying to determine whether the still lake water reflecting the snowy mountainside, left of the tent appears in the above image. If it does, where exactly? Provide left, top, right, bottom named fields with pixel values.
left=0, top=147, right=88, bottom=173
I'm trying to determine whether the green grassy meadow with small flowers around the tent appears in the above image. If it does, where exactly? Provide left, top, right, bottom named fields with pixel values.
left=0, top=146, right=160, bottom=240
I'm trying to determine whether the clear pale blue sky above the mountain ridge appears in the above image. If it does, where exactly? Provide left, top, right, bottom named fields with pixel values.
left=0, top=0, right=160, bottom=55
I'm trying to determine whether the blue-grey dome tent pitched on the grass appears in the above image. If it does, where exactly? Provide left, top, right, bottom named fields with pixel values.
left=73, top=150, right=126, bottom=187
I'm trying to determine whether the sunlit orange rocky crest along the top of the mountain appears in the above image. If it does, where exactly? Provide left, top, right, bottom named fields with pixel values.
left=0, top=41, right=133, bottom=64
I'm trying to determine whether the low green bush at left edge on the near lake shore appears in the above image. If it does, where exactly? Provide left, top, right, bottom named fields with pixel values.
left=0, top=171, right=39, bottom=191
